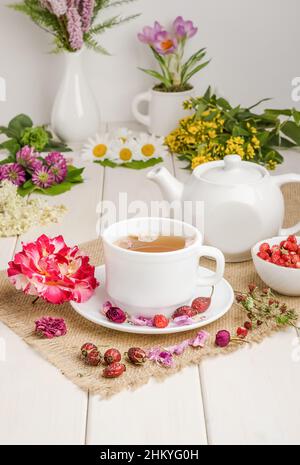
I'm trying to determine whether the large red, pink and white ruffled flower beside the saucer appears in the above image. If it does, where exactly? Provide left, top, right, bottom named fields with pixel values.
left=7, top=235, right=99, bottom=304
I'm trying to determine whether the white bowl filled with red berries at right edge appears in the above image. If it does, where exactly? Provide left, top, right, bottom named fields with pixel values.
left=251, top=236, right=300, bottom=296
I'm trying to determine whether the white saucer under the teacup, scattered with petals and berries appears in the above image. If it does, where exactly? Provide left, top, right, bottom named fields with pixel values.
left=71, top=265, right=234, bottom=334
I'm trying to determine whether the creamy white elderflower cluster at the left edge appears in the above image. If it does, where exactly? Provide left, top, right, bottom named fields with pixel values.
left=0, top=180, right=67, bottom=237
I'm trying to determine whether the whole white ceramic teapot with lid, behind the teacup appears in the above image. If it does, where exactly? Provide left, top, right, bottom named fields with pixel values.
left=148, top=155, right=300, bottom=262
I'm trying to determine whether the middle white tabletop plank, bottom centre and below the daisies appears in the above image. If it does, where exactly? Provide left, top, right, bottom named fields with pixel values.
left=87, top=124, right=207, bottom=445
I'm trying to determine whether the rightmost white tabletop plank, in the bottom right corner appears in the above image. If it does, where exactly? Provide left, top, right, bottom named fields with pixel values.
left=200, top=329, right=300, bottom=445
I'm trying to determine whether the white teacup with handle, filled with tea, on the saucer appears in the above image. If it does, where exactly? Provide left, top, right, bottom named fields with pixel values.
left=102, top=218, right=225, bottom=317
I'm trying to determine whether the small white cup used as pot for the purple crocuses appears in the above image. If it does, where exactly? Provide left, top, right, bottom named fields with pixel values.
left=132, top=89, right=194, bottom=136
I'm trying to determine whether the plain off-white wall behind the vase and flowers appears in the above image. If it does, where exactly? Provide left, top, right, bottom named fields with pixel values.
left=0, top=0, right=300, bottom=124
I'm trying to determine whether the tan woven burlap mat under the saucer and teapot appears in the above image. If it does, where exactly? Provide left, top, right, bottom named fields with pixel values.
left=0, top=184, right=300, bottom=397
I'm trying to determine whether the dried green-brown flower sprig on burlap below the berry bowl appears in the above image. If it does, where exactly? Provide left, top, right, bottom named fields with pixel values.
left=236, top=284, right=299, bottom=329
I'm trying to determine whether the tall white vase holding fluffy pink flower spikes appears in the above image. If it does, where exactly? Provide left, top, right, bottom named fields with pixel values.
left=51, top=50, right=100, bottom=143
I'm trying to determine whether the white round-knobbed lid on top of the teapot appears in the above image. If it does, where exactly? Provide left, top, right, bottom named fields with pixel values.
left=195, top=155, right=266, bottom=185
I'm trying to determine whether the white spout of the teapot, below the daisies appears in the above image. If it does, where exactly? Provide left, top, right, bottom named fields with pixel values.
left=147, top=166, right=183, bottom=202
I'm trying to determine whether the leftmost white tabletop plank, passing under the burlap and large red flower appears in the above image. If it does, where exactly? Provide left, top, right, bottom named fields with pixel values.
left=0, top=141, right=104, bottom=444
